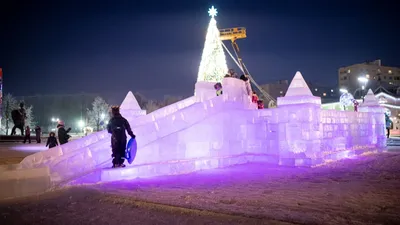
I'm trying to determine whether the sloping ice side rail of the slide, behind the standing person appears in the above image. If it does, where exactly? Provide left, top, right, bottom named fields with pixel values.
left=33, top=97, right=247, bottom=185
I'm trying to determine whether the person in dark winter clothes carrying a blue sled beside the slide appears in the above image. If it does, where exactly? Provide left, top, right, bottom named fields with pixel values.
left=107, top=106, right=135, bottom=168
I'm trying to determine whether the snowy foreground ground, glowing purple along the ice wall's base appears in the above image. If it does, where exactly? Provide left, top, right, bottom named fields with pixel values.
left=0, top=147, right=400, bottom=224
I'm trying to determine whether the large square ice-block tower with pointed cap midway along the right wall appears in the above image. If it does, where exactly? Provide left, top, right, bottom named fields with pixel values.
left=278, top=71, right=321, bottom=165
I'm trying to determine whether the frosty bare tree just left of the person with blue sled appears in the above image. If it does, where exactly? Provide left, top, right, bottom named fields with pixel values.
left=88, top=97, right=109, bottom=131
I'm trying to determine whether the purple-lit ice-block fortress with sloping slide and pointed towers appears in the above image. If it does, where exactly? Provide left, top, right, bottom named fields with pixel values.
left=4, top=72, right=386, bottom=195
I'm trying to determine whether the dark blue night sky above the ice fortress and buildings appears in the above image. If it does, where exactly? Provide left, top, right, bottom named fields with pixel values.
left=0, top=0, right=400, bottom=100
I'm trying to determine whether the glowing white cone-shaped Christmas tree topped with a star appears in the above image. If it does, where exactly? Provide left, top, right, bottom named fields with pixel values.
left=197, top=6, right=228, bottom=82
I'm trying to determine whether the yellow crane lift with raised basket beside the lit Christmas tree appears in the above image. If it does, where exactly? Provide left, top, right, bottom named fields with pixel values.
left=219, top=27, right=275, bottom=106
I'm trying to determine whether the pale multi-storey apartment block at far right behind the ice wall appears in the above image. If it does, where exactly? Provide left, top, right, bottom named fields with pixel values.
left=338, top=59, right=400, bottom=98
